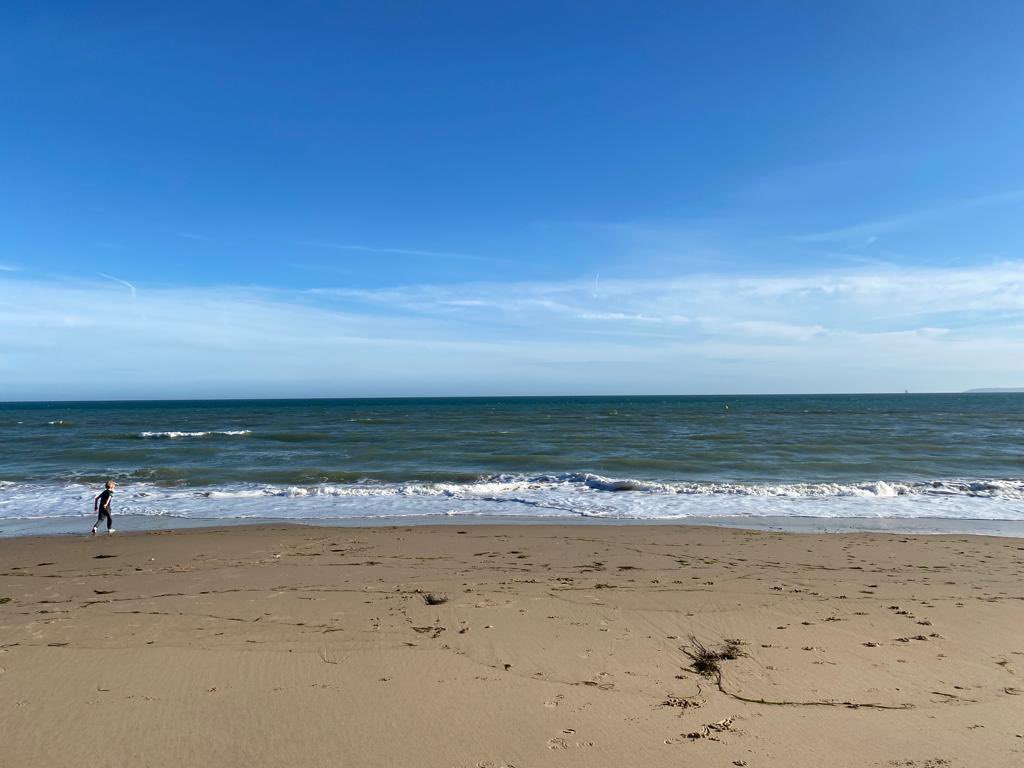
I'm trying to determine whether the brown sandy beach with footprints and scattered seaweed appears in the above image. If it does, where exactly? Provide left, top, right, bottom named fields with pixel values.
left=0, top=524, right=1024, bottom=768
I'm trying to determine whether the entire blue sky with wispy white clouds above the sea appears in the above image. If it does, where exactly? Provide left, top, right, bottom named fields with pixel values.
left=0, top=0, right=1024, bottom=399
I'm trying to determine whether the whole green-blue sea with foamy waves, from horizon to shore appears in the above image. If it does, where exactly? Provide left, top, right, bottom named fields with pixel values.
left=0, top=393, right=1024, bottom=536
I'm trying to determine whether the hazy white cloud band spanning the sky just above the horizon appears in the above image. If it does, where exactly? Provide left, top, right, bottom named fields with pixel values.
left=6, top=261, right=1024, bottom=399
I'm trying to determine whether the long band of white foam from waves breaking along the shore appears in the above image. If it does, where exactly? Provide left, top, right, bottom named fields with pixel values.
left=0, top=473, right=1024, bottom=521
